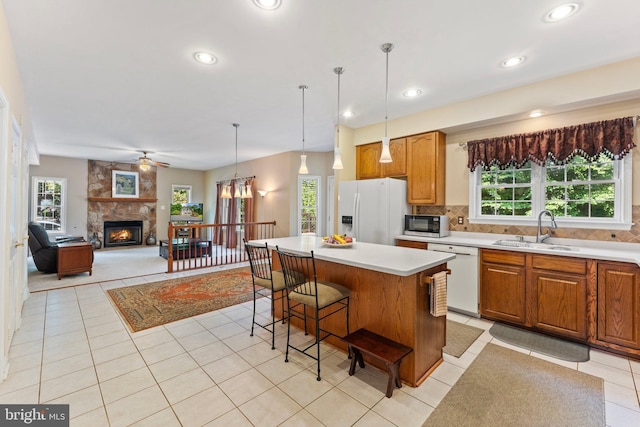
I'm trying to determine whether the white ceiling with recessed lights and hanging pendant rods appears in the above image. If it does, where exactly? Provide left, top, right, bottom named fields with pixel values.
left=2, top=0, right=640, bottom=170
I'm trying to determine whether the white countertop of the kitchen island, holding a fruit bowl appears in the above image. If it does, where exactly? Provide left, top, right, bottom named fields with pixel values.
left=252, top=236, right=455, bottom=276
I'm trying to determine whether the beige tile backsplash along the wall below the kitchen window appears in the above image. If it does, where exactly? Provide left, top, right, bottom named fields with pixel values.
left=416, top=205, right=640, bottom=243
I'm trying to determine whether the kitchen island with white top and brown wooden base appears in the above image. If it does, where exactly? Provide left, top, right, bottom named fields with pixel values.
left=253, top=236, right=455, bottom=387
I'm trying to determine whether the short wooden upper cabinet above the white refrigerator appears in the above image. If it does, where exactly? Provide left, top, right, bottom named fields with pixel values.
left=356, top=138, right=407, bottom=179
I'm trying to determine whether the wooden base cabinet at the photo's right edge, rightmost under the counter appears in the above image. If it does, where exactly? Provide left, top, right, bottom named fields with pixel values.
left=596, top=261, right=640, bottom=349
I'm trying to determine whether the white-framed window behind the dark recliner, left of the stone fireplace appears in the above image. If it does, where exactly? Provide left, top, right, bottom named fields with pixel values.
left=31, top=176, right=67, bottom=233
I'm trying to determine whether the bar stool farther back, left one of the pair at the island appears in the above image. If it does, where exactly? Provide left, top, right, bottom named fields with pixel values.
left=242, top=239, right=286, bottom=350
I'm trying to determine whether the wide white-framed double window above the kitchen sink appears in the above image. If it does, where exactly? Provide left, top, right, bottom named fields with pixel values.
left=469, top=155, right=632, bottom=229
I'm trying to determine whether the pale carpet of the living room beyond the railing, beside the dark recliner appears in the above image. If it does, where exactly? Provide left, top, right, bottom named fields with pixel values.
left=27, top=246, right=167, bottom=292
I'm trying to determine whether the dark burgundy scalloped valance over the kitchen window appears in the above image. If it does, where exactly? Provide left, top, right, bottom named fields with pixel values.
left=467, top=117, right=636, bottom=171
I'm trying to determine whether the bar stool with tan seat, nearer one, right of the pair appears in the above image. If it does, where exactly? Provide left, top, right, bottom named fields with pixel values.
left=276, top=246, right=350, bottom=381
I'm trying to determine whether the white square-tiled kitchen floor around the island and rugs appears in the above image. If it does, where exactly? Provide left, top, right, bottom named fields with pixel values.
left=0, top=270, right=640, bottom=427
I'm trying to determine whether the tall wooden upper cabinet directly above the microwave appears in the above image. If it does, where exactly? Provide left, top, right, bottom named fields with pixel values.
left=407, top=132, right=446, bottom=206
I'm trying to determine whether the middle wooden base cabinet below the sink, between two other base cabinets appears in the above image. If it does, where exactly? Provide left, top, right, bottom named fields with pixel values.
left=526, top=255, right=588, bottom=341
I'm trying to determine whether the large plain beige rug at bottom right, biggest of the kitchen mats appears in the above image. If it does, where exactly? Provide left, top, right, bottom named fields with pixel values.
left=423, top=344, right=605, bottom=427
